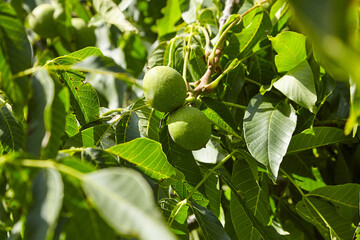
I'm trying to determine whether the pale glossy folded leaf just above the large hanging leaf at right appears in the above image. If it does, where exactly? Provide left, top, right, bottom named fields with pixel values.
left=274, top=61, right=317, bottom=112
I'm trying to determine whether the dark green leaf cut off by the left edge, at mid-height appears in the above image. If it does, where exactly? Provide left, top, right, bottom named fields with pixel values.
left=0, top=105, right=24, bottom=153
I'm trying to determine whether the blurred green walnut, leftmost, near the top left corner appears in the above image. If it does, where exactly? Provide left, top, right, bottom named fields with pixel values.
left=28, top=3, right=58, bottom=38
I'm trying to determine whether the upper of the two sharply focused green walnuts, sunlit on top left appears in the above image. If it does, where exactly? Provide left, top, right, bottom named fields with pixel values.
left=143, top=66, right=186, bottom=112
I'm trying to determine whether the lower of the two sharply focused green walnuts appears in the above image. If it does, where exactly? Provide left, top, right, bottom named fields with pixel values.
left=168, top=105, right=211, bottom=150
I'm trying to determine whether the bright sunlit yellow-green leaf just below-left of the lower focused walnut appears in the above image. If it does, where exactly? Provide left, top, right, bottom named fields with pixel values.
left=106, top=138, right=176, bottom=180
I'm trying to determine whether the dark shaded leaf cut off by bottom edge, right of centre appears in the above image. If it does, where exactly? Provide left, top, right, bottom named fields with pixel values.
left=192, top=203, right=230, bottom=240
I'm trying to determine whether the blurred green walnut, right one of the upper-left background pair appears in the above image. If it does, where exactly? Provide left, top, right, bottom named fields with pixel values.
left=71, top=18, right=96, bottom=49
